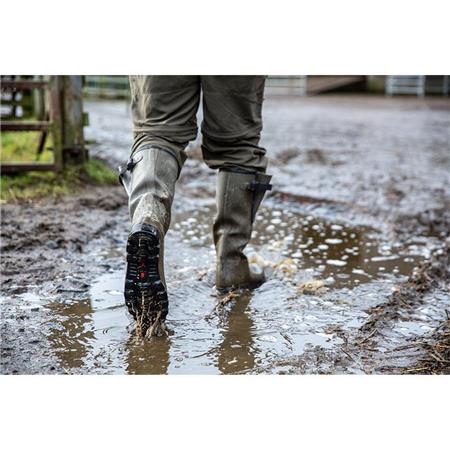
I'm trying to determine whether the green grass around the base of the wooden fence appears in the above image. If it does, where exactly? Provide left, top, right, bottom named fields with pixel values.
left=0, top=132, right=117, bottom=202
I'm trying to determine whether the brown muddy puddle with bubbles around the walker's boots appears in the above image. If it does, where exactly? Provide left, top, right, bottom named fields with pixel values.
left=14, top=203, right=432, bottom=374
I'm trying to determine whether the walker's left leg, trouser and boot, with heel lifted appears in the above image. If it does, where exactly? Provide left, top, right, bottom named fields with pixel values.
left=121, top=76, right=200, bottom=335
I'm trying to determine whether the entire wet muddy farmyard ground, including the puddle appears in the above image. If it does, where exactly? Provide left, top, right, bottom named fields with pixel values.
left=1, top=95, right=450, bottom=374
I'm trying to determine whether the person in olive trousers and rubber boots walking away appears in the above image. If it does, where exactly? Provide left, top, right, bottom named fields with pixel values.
left=120, top=75, right=271, bottom=337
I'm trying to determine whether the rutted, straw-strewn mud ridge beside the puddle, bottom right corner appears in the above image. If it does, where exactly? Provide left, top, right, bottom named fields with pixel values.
left=268, top=241, right=450, bottom=374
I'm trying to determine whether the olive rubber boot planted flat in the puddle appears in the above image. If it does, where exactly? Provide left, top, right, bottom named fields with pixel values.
left=213, top=170, right=272, bottom=291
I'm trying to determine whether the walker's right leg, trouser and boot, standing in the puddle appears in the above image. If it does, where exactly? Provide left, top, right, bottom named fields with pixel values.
left=201, top=76, right=271, bottom=289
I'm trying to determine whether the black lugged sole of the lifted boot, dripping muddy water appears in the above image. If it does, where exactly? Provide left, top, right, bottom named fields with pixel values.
left=124, top=224, right=169, bottom=336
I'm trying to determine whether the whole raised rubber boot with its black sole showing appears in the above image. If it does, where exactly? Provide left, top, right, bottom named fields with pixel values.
left=120, top=147, right=179, bottom=337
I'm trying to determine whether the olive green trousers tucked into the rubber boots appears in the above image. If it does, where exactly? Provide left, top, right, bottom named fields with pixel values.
left=130, top=75, right=267, bottom=172
